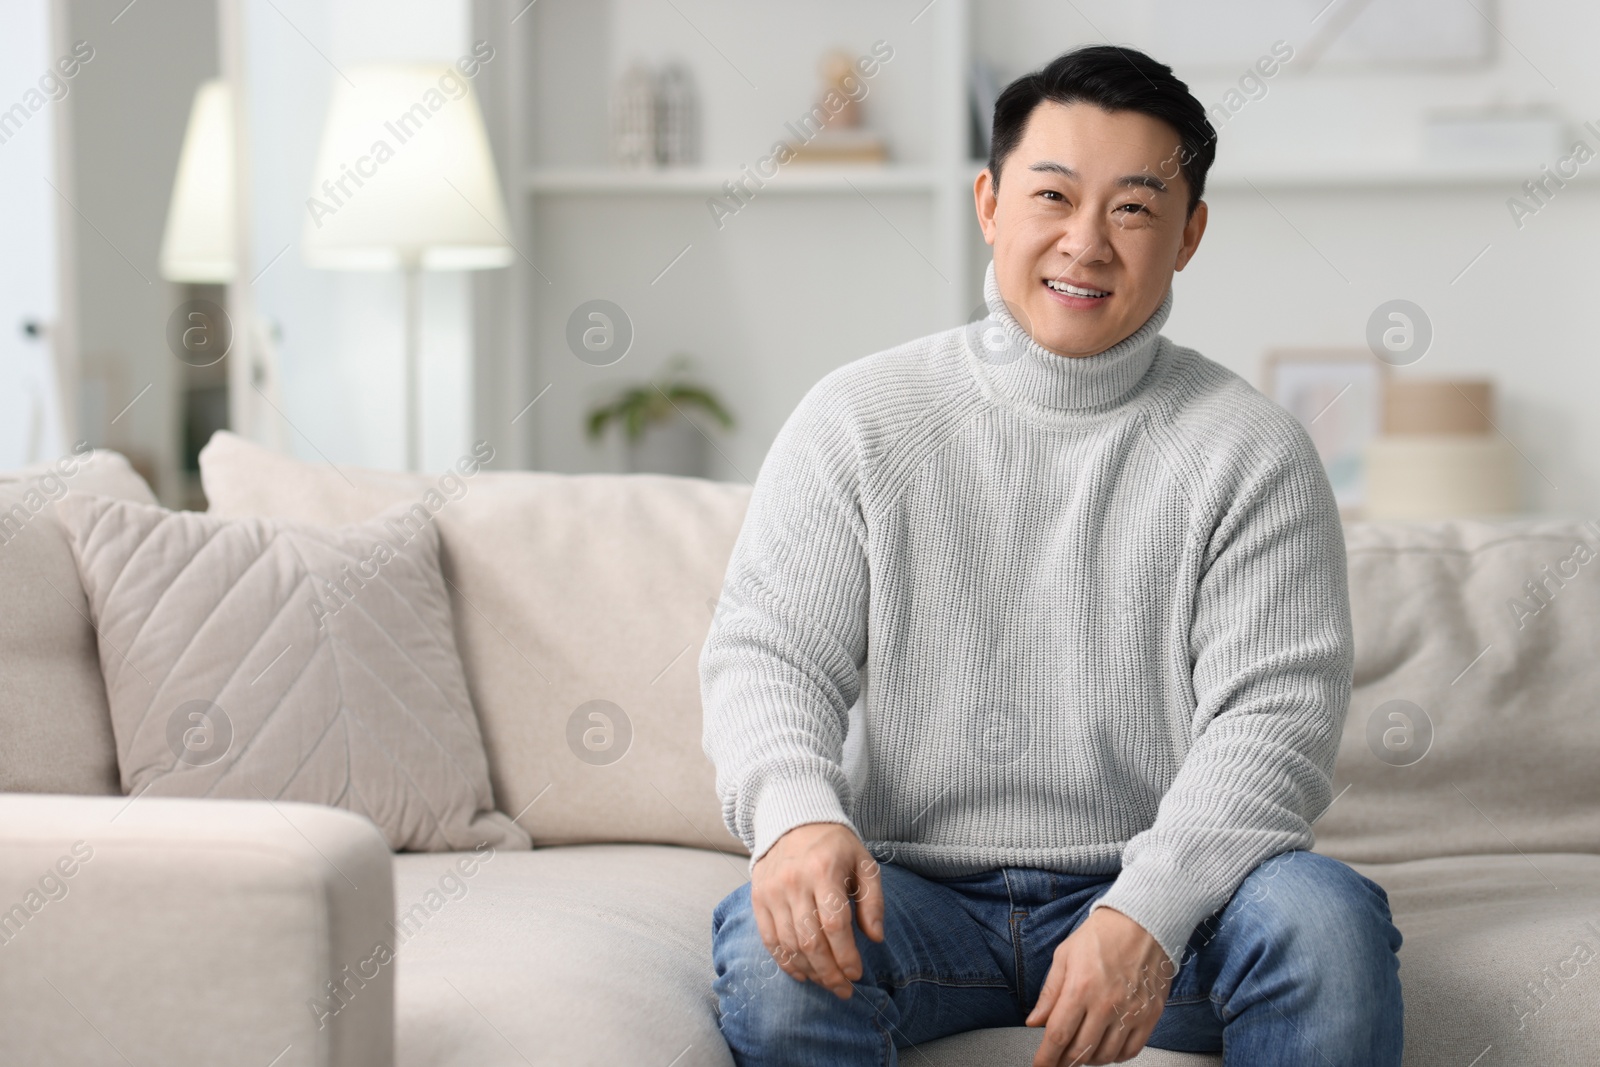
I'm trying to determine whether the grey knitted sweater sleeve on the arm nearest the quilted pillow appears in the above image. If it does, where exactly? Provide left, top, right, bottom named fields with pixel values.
left=699, top=374, right=867, bottom=870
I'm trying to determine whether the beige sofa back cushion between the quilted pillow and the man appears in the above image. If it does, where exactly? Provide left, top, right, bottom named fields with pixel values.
left=200, top=434, right=749, bottom=853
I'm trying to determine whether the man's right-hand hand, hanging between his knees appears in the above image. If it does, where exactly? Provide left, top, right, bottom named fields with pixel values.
left=1026, top=907, right=1176, bottom=1067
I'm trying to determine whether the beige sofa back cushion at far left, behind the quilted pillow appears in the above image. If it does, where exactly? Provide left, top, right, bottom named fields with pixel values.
left=0, top=450, right=155, bottom=795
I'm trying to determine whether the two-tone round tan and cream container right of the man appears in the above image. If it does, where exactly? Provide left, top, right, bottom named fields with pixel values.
left=1363, top=378, right=1518, bottom=520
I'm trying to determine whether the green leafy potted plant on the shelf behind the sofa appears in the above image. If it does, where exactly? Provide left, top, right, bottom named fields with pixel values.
left=587, top=352, right=734, bottom=478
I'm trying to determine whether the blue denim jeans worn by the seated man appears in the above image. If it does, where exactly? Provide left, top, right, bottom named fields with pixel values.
left=712, top=849, right=1402, bottom=1067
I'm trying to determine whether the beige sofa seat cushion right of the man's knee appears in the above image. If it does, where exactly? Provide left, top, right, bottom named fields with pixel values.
left=1352, top=853, right=1600, bottom=1067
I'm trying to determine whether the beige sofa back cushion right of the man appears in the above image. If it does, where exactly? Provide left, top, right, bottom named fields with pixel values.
left=1317, top=520, right=1600, bottom=862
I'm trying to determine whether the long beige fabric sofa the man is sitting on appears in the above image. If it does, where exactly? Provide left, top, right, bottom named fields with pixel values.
left=0, top=435, right=1600, bottom=1067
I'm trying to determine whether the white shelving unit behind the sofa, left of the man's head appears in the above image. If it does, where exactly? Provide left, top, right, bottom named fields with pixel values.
left=475, top=0, right=987, bottom=480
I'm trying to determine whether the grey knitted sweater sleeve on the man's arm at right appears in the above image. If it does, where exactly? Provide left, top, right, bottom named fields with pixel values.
left=1091, top=435, right=1355, bottom=965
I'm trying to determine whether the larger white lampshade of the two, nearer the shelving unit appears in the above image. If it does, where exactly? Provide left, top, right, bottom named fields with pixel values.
left=302, top=64, right=512, bottom=270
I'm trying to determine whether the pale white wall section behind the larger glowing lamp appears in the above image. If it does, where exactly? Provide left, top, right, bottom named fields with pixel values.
left=245, top=0, right=472, bottom=469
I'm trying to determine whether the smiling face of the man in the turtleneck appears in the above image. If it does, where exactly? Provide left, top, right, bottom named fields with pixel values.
left=973, top=101, right=1206, bottom=363
